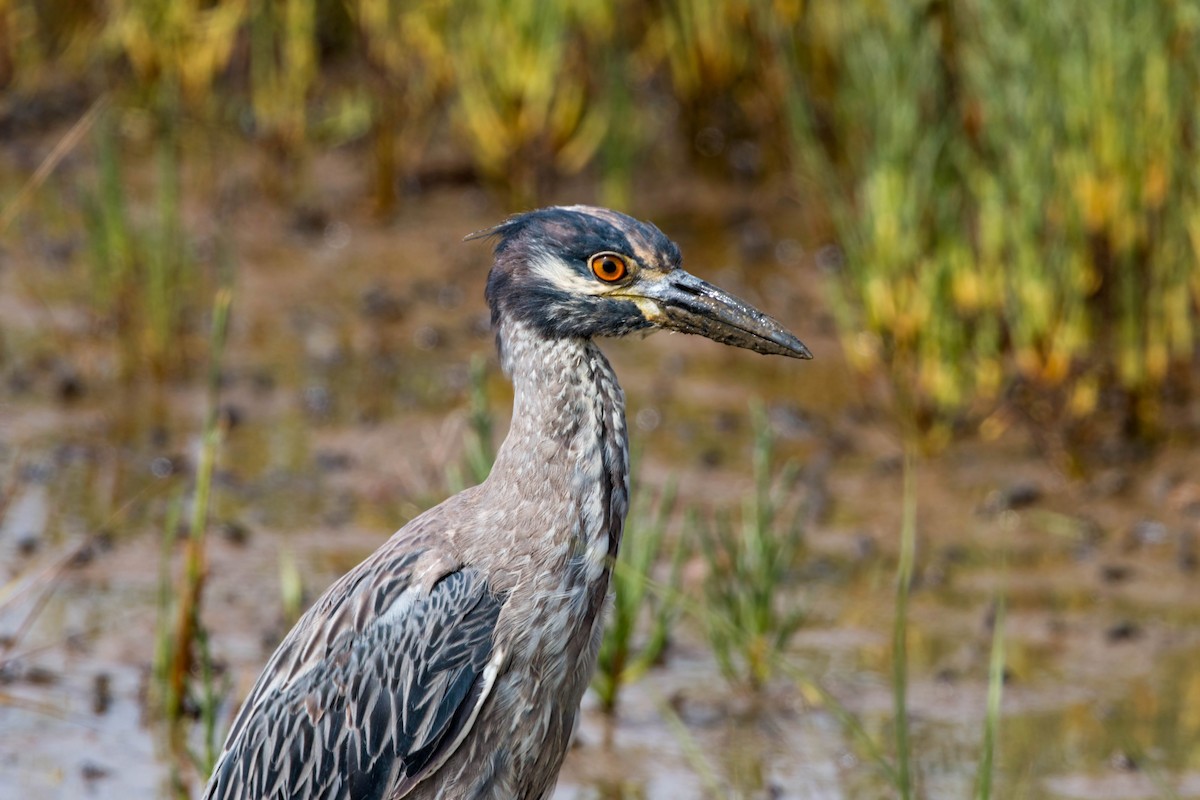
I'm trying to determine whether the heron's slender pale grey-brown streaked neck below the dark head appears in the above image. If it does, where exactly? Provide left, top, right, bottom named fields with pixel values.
left=488, top=323, right=629, bottom=573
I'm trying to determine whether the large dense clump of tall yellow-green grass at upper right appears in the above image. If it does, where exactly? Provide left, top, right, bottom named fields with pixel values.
left=792, top=0, right=1200, bottom=441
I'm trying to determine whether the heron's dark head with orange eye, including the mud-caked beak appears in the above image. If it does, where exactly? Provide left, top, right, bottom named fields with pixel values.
left=470, top=205, right=812, bottom=359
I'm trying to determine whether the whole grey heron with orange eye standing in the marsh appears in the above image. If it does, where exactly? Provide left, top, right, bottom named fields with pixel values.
left=205, top=206, right=811, bottom=800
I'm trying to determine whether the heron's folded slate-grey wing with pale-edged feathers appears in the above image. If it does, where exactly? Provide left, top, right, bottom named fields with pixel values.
left=205, top=569, right=503, bottom=800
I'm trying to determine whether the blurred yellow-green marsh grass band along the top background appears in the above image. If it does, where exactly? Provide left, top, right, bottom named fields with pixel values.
left=0, top=0, right=1200, bottom=450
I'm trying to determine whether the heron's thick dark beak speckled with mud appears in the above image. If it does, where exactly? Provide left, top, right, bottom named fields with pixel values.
left=630, top=269, right=812, bottom=359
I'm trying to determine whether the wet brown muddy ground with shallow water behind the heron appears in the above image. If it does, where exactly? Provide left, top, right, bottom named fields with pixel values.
left=0, top=143, right=1200, bottom=799
